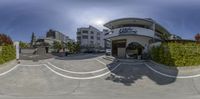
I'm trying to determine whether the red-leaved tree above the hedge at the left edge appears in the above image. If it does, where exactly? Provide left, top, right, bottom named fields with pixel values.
left=0, top=34, right=13, bottom=46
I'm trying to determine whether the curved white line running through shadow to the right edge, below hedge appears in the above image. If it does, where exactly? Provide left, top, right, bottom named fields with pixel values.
left=144, top=63, right=200, bottom=79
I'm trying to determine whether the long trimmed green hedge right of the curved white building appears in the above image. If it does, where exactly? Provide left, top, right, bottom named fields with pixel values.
left=151, top=42, right=200, bottom=66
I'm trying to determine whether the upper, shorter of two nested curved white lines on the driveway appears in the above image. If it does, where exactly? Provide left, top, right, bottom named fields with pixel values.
left=47, top=62, right=108, bottom=74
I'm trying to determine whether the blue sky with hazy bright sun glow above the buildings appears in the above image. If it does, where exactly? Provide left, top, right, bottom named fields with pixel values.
left=0, top=0, right=200, bottom=41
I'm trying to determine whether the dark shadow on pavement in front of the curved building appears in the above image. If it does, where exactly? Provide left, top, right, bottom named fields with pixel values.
left=106, top=62, right=178, bottom=86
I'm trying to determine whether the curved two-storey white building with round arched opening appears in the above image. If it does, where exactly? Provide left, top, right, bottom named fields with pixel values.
left=104, top=18, right=171, bottom=58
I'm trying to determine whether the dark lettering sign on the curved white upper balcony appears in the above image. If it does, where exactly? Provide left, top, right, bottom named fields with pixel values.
left=119, top=27, right=137, bottom=34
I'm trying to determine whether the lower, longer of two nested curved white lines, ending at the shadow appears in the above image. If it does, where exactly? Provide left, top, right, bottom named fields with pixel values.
left=44, top=64, right=121, bottom=80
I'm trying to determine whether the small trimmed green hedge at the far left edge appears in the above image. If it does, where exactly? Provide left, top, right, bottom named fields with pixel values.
left=0, top=45, right=16, bottom=64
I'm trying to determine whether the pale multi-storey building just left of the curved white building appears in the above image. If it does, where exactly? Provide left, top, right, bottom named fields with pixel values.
left=77, top=26, right=105, bottom=49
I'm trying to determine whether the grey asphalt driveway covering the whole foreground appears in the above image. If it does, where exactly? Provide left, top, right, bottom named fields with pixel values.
left=0, top=55, right=200, bottom=99
